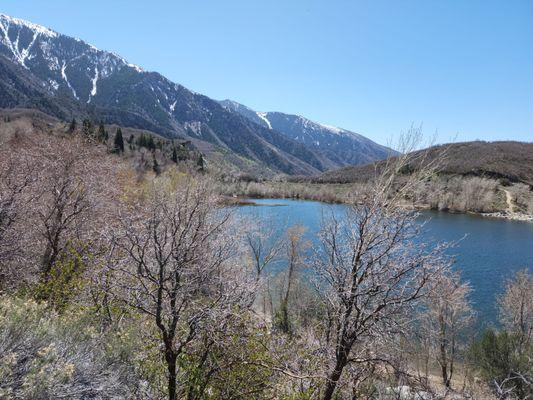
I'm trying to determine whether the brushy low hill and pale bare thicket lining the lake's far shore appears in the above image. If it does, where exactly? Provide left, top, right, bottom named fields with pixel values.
left=241, top=142, right=533, bottom=220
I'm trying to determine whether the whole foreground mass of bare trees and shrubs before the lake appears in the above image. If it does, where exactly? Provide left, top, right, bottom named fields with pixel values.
left=0, top=122, right=533, bottom=400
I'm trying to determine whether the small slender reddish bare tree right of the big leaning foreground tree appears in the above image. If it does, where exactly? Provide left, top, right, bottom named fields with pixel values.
left=421, top=271, right=474, bottom=388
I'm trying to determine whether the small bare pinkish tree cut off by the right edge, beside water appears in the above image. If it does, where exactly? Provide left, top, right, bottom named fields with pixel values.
left=498, top=269, right=533, bottom=344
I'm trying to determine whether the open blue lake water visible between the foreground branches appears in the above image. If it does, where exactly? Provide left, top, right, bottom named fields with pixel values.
left=237, top=199, right=533, bottom=326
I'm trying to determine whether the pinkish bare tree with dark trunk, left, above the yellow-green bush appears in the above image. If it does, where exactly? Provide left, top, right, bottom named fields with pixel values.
left=32, top=137, right=115, bottom=279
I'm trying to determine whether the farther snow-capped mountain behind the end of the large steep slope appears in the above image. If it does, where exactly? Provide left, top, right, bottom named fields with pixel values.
left=220, top=100, right=394, bottom=166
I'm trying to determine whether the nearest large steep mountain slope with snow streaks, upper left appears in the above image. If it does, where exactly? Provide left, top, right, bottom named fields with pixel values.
left=0, top=14, right=328, bottom=174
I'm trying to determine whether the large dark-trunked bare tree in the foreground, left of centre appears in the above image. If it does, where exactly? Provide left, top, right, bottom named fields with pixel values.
left=109, top=179, right=253, bottom=400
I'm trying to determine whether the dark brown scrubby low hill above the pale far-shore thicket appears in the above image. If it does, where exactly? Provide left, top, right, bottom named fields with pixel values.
left=310, top=141, right=533, bottom=185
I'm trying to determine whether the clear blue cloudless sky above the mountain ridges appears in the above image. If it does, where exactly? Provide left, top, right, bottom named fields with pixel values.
left=0, top=0, right=533, bottom=143
